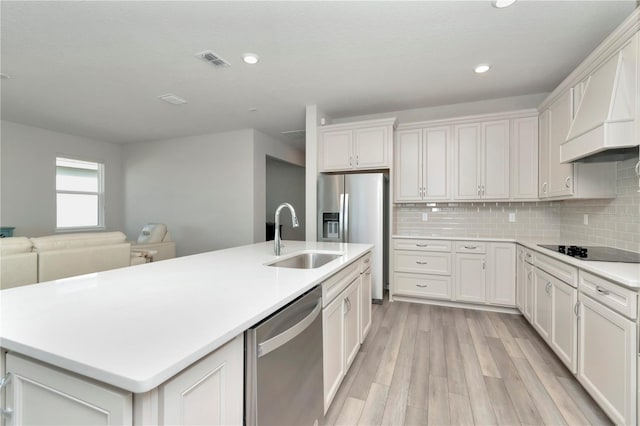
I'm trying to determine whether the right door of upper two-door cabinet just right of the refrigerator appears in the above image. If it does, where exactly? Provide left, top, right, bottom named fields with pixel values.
left=422, top=127, right=451, bottom=201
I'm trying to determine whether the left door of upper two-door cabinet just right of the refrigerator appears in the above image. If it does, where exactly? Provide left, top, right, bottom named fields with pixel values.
left=394, top=129, right=423, bottom=202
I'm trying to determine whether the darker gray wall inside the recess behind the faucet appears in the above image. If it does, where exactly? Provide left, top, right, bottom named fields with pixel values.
left=265, top=157, right=306, bottom=241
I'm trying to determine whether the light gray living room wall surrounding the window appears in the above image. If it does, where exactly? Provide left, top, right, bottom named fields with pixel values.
left=0, top=121, right=124, bottom=237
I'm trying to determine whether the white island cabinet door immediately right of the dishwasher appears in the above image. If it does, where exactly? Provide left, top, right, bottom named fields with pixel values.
left=322, top=296, right=345, bottom=413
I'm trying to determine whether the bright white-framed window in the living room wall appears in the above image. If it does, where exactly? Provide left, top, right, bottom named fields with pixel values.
left=56, top=157, right=104, bottom=229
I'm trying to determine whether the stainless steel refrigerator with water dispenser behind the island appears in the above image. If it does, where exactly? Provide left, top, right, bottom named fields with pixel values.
left=318, top=173, right=389, bottom=302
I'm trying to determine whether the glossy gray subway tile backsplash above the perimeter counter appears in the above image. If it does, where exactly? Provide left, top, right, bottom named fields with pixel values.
left=393, top=158, right=640, bottom=251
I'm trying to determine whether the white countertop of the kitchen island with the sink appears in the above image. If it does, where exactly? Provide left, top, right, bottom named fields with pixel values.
left=0, top=241, right=372, bottom=393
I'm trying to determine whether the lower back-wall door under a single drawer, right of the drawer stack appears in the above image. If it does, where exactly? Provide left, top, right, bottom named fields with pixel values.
left=455, top=253, right=486, bottom=303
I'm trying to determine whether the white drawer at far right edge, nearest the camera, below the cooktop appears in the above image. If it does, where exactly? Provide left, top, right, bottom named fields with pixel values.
left=578, top=271, right=638, bottom=319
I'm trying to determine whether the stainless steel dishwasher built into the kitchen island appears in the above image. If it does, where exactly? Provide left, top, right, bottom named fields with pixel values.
left=245, top=286, right=324, bottom=426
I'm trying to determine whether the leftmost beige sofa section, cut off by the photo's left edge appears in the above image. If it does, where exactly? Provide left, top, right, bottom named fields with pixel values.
left=0, top=237, right=38, bottom=290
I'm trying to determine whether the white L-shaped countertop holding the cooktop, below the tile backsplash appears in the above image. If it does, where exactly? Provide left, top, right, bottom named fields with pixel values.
left=392, top=235, right=640, bottom=290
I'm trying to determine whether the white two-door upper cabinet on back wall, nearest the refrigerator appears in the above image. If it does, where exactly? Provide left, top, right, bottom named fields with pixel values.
left=394, top=126, right=451, bottom=202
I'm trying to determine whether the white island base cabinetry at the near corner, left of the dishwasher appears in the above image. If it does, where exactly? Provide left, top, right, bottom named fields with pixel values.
left=5, top=335, right=244, bottom=425
